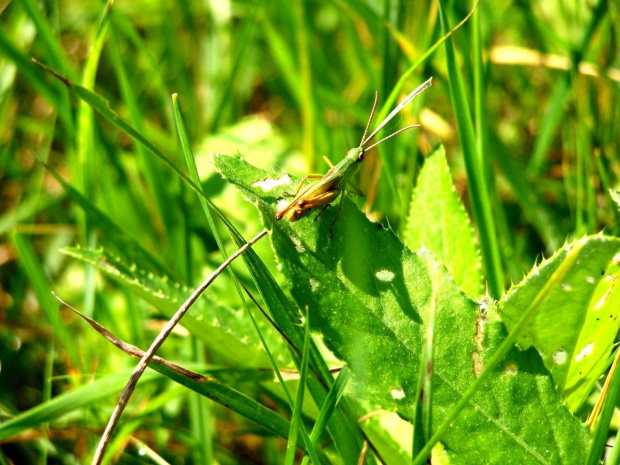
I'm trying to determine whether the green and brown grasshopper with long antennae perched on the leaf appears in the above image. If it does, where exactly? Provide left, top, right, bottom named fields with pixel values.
left=276, top=78, right=433, bottom=237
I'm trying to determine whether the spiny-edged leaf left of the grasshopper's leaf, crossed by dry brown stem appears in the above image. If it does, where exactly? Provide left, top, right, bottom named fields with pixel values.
left=63, top=247, right=289, bottom=367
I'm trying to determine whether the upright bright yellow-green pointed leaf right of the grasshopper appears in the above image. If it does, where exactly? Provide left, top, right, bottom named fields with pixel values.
left=405, top=146, right=482, bottom=298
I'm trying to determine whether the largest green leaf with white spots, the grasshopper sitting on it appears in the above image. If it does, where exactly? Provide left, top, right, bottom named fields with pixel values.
left=215, top=156, right=589, bottom=463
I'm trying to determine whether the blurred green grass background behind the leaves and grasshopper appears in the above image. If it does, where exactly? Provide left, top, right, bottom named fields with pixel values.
left=0, top=0, right=620, bottom=463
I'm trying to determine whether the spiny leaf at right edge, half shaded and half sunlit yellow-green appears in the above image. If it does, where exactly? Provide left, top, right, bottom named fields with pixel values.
left=500, top=235, right=620, bottom=409
